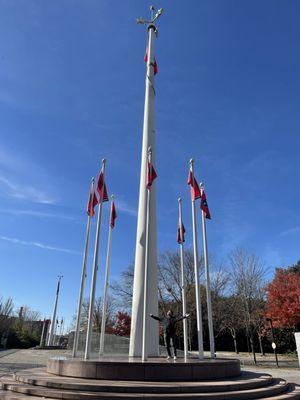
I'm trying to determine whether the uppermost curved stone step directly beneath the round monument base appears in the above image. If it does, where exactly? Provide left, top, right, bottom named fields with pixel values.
left=14, top=368, right=273, bottom=393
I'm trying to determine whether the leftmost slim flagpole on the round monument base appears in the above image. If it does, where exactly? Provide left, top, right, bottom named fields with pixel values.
left=72, top=178, right=95, bottom=357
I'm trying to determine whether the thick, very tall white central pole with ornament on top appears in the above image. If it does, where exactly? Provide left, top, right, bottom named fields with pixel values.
left=129, top=6, right=162, bottom=357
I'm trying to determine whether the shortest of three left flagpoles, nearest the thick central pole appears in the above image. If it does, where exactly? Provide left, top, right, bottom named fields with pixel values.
left=99, top=194, right=115, bottom=356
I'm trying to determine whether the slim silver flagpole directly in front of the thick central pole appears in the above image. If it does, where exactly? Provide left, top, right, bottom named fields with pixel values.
left=142, top=147, right=152, bottom=361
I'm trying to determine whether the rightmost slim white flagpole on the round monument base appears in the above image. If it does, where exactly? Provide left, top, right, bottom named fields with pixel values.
left=200, top=183, right=216, bottom=358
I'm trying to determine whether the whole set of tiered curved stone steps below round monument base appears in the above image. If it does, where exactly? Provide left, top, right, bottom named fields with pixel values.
left=0, top=368, right=300, bottom=400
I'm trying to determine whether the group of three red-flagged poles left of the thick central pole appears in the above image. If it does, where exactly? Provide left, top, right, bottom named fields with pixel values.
left=73, top=159, right=117, bottom=359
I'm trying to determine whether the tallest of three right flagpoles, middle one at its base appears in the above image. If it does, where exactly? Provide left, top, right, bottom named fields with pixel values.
left=190, top=159, right=204, bottom=360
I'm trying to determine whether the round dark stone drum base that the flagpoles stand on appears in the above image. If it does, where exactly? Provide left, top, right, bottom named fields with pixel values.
left=47, top=357, right=241, bottom=381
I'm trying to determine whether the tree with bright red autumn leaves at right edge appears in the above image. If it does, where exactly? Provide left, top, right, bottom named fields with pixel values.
left=266, top=267, right=300, bottom=329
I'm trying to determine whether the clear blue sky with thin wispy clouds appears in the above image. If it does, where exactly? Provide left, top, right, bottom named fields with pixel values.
left=0, top=0, right=300, bottom=328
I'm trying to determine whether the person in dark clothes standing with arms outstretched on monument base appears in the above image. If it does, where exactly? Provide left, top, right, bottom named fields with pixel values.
left=150, top=310, right=190, bottom=360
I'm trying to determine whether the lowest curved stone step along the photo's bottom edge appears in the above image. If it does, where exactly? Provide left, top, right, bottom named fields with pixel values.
left=6, top=380, right=289, bottom=400
